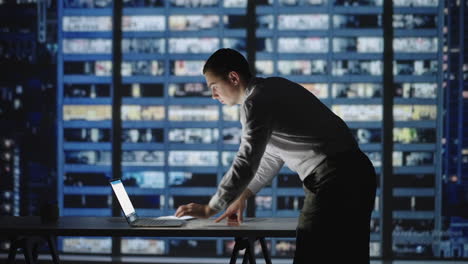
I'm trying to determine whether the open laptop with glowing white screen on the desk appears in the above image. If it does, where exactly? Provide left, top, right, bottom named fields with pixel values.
left=110, top=179, right=185, bottom=227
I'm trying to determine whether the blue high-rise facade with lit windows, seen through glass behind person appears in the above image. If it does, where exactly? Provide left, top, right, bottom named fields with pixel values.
left=58, top=0, right=442, bottom=257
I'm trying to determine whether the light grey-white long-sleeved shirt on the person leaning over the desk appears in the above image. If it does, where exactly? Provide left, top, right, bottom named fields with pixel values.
left=208, top=77, right=357, bottom=211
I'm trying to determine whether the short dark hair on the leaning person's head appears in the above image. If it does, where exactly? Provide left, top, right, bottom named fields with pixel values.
left=203, top=49, right=252, bottom=81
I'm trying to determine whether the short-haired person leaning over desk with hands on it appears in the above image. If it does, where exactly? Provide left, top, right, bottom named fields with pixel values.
left=175, top=49, right=376, bottom=264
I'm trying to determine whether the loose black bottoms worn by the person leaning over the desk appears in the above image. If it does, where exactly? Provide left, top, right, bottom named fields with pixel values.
left=294, top=150, right=377, bottom=264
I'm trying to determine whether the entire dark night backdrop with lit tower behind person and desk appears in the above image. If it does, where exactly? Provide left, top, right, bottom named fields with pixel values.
left=0, top=0, right=468, bottom=263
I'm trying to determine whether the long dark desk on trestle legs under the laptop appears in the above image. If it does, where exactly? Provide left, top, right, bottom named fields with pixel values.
left=0, top=216, right=298, bottom=264
